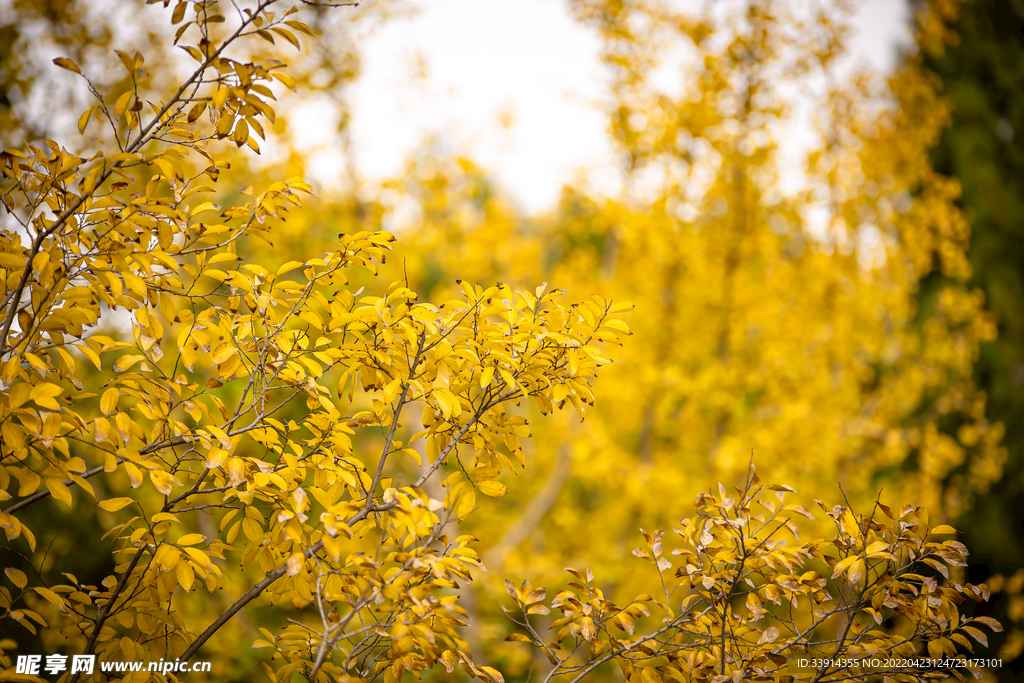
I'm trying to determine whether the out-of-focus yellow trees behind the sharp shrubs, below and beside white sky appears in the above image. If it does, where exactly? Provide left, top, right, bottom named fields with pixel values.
left=364, top=0, right=1005, bottom=666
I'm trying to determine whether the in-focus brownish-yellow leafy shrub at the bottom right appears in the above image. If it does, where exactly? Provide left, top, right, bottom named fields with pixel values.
left=506, top=466, right=1002, bottom=683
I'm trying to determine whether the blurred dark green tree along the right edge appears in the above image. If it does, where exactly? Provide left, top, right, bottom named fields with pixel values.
left=922, top=0, right=1024, bottom=680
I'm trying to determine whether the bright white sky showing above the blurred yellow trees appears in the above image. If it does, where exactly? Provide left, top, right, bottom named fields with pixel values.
left=296, top=0, right=909, bottom=213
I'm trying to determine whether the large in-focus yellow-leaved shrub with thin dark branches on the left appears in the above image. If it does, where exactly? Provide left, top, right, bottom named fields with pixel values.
left=0, top=0, right=631, bottom=681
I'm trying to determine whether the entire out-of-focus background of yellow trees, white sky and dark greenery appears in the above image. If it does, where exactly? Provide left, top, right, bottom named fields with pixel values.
left=0, top=0, right=1024, bottom=681
